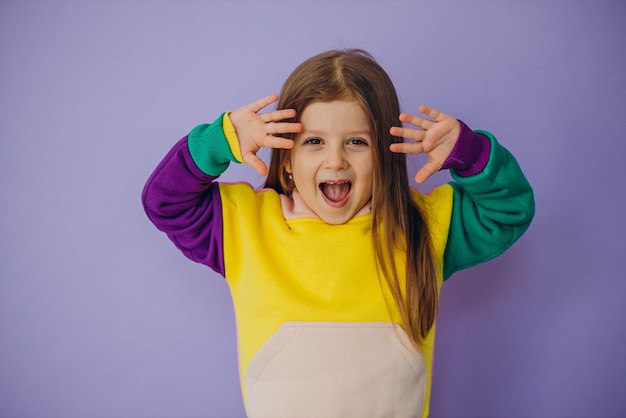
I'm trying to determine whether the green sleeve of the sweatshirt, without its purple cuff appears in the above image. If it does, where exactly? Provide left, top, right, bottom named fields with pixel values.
left=444, top=131, right=535, bottom=280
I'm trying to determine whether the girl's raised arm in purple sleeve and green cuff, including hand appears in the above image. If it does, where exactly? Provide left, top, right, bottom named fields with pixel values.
left=142, top=96, right=299, bottom=275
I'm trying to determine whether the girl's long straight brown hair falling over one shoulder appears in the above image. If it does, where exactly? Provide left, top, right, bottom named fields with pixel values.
left=265, top=49, right=439, bottom=347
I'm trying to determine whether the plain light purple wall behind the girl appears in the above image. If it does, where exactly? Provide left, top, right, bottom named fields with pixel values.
left=0, top=0, right=626, bottom=418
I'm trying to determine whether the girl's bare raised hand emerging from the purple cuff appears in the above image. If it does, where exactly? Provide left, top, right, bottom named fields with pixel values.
left=389, top=105, right=461, bottom=183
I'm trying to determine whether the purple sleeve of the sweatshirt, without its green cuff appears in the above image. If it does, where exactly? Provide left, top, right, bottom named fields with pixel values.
left=142, top=137, right=224, bottom=276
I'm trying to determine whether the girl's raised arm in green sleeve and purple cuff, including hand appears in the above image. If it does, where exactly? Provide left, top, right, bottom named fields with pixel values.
left=391, top=106, right=535, bottom=278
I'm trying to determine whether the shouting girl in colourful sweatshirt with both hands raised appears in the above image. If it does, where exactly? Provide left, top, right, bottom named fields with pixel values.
left=143, top=50, right=534, bottom=417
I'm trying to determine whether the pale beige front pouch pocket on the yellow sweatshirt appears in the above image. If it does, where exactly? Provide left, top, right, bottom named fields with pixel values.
left=245, top=322, right=426, bottom=418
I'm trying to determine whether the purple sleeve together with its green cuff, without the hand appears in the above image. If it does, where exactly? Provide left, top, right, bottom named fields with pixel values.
left=142, top=119, right=236, bottom=275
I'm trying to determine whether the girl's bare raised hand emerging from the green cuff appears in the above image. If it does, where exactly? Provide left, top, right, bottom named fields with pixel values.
left=229, top=94, right=302, bottom=176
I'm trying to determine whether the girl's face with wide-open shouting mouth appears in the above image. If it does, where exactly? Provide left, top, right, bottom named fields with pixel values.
left=285, top=100, right=374, bottom=224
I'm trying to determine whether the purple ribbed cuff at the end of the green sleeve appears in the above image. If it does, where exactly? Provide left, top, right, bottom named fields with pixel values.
left=441, top=120, right=491, bottom=177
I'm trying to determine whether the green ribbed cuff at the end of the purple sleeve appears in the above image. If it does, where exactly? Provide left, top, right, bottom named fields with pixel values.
left=187, top=114, right=239, bottom=176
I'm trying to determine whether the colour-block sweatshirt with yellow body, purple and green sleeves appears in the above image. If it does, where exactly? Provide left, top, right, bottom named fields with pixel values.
left=143, top=114, right=534, bottom=418
